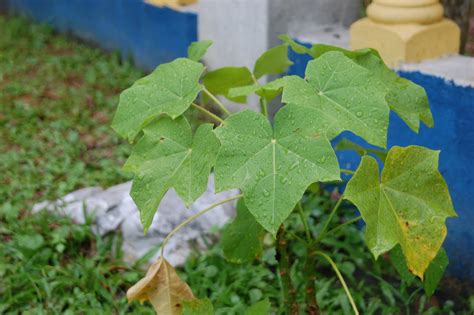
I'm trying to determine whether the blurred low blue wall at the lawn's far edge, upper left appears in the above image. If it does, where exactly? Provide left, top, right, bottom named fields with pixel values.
left=7, top=0, right=197, bottom=70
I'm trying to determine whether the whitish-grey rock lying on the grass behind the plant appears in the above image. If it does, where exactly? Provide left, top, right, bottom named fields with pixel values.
left=33, top=176, right=238, bottom=266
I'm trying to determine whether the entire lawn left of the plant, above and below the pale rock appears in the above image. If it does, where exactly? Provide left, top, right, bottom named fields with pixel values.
left=0, top=16, right=150, bottom=314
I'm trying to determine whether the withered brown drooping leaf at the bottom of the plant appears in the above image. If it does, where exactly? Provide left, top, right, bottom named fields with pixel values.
left=127, top=257, right=194, bottom=315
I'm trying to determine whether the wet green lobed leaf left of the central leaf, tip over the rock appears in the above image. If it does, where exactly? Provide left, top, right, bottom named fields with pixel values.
left=124, top=116, right=219, bottom=230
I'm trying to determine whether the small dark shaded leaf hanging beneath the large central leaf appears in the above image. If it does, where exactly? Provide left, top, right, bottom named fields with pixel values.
left=221, top=199, right=265, bottom=264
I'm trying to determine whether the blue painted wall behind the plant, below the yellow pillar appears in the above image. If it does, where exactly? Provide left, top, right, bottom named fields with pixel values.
left=289, top=46, right=474, bottom=280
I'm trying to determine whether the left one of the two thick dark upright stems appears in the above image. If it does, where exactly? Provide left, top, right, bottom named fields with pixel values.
left=276, top=225, right=299, bottom=315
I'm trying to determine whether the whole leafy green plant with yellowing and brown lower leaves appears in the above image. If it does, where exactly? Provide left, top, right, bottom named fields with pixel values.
left=112, top=36, right=456, bottom=314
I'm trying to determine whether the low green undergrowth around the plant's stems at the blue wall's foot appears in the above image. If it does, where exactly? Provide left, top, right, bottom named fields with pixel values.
left=183, top=192, right=474, bottom=315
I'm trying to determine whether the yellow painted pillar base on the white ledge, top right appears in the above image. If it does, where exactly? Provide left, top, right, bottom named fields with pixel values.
left=350, top=0, right=461, bottom=66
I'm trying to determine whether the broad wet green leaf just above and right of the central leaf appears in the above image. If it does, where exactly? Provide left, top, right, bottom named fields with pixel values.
left=282, top=52, right=390, bottom=147
